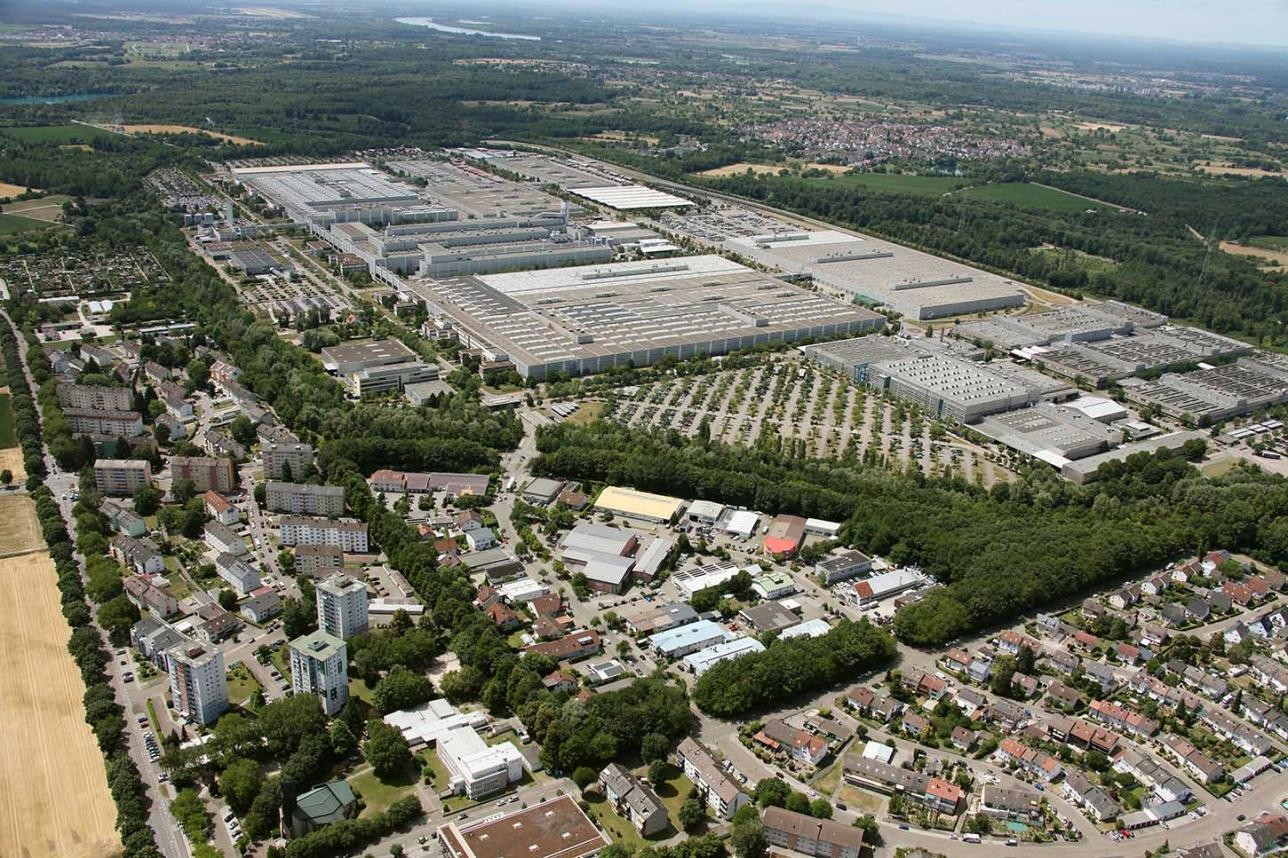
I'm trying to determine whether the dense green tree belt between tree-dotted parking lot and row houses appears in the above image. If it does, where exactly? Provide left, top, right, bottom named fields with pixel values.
left=533, top=424, right=1288, bottom=645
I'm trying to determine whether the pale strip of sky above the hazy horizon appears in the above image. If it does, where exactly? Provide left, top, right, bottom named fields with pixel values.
left=762, top=0, right=1288, bottom=50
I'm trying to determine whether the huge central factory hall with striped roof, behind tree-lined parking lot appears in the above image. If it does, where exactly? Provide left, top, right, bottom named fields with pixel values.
left=404, top=255, right=885, bottom=380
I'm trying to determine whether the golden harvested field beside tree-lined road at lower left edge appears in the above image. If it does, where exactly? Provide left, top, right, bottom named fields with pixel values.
left=0, top=497, right=121, bottom=858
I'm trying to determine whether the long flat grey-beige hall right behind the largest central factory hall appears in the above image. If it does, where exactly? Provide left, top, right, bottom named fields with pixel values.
left=725, top=229, right=1025, bottom=321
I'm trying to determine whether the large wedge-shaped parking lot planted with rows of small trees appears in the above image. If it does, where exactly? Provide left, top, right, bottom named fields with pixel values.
left=604, top=359, right=1010, bottom=486
